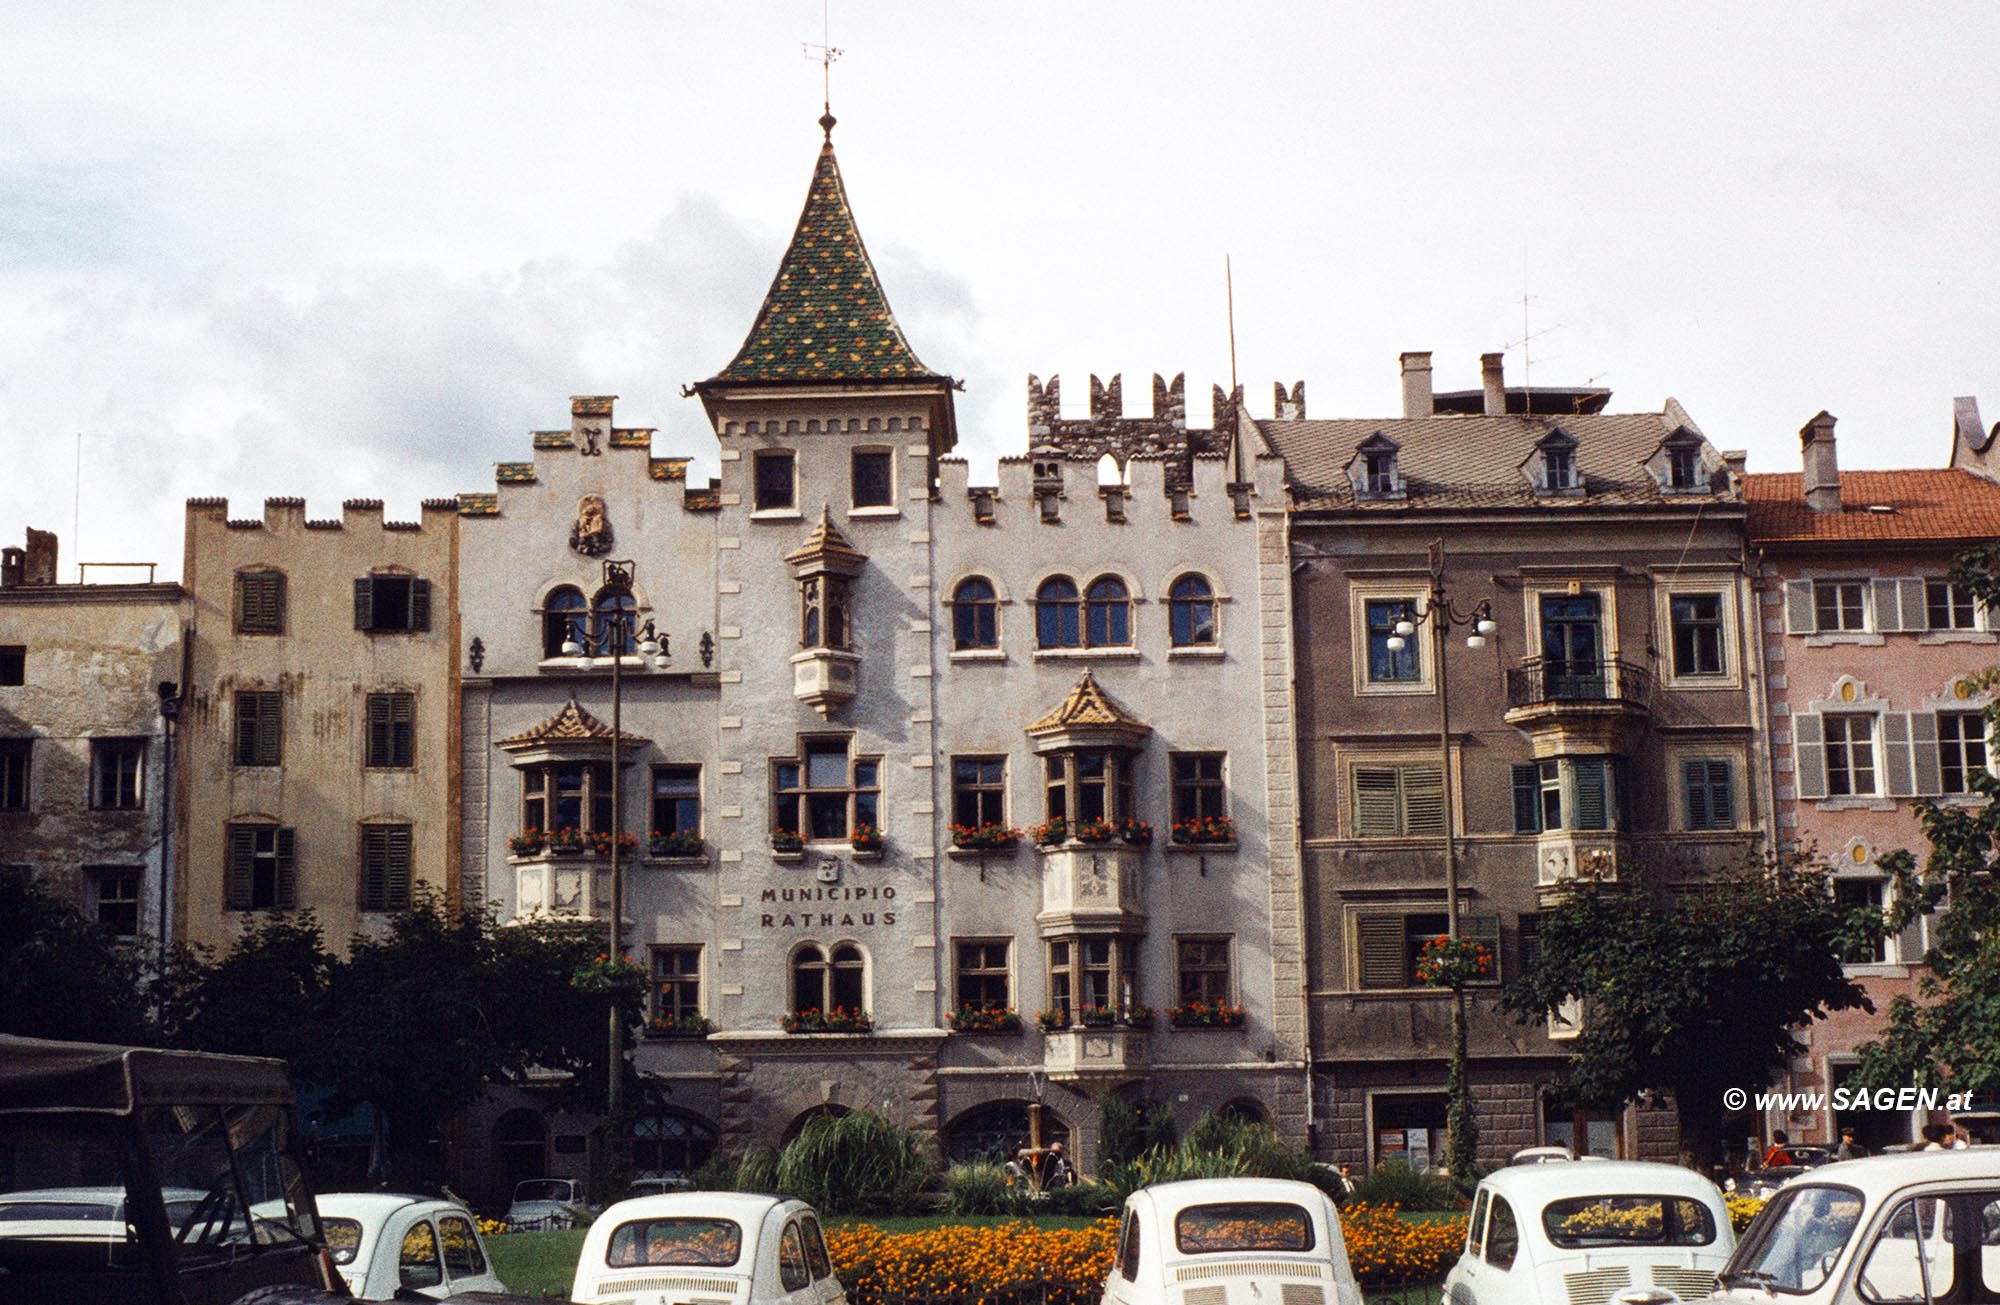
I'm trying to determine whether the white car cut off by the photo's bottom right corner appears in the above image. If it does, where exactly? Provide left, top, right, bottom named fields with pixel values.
left=1708, top=1147, right=2000, bottom=1305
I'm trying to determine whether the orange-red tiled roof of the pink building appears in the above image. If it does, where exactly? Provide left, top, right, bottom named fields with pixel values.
left=1744, top=468, right=2000, bottom=542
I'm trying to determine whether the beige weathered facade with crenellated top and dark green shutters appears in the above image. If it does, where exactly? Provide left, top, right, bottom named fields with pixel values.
left=174, top=498, right=458, bottom=951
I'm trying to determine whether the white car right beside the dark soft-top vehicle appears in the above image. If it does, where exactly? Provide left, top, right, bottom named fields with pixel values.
left=320, top=1191, right=506, bottom=1301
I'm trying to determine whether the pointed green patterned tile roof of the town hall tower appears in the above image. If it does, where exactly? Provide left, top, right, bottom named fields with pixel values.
left=704, top=140, right=938, bottom=384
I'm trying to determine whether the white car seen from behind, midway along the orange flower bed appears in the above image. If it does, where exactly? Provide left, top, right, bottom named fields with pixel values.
left=1104, top=1179, right=1362, bottom=1305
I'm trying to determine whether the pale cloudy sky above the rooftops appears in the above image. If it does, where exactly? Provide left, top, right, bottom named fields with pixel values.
left=0, top=0, right=2000, bottom=578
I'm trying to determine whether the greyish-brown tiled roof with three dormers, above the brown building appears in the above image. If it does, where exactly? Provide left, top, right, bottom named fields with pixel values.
left=1256, top=410, right=1714, bottom=512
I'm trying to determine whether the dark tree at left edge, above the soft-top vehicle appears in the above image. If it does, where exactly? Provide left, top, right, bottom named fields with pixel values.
left=0, top=865, right=154, bottom=1043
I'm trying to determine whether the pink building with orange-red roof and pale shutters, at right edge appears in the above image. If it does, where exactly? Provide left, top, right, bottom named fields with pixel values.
left=1732, top=400, right=2000, bottom=1149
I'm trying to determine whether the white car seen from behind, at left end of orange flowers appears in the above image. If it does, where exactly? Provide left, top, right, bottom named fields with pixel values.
left=570, top=1191, right=848, bottom=1305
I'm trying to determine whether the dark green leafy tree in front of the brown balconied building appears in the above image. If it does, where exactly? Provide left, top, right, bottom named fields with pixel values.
left=1502, top=855, right=1880, bottom=1163
